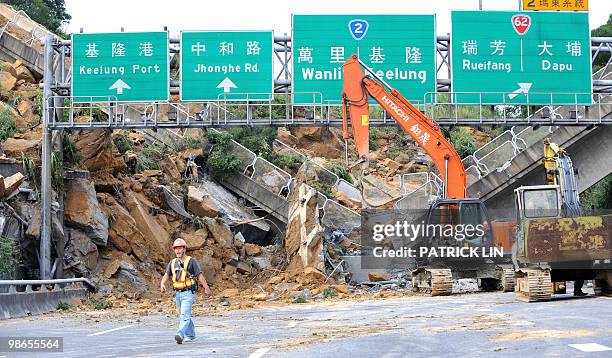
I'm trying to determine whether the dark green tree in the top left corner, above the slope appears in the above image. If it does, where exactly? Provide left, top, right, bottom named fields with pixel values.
left=4, top=0, right=72, bottom=35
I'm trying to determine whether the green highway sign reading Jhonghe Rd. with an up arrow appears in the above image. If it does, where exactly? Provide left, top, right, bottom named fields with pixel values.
left=181, top=31, right=274, bottom=101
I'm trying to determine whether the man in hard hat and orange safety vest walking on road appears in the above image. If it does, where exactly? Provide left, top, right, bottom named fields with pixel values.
left=160, top=239, right=210, bottom=344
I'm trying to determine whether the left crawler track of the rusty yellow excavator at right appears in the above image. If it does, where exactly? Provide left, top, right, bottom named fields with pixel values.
left=515, top=269, right=552, bottom=302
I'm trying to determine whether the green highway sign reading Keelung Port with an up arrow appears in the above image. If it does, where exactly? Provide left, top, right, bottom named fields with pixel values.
left=72, top=31, right=170, bottom=103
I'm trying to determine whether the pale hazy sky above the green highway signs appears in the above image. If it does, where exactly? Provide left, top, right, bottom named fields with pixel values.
left=65, top=0, right=612, bottom=36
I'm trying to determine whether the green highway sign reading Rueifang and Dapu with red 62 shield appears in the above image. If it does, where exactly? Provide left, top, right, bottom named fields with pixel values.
left=451, top=11, right=592, bottom=105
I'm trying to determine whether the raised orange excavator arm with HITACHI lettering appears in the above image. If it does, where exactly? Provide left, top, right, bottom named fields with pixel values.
left=342, top=55, right=466, bottom=199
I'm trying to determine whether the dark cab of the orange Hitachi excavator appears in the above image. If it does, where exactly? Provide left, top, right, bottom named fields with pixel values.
left=427, top=198, right=493, bottom=246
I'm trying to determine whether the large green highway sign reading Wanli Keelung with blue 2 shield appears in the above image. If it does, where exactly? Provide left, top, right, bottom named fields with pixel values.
left=292, top=15, right=436, bottom=104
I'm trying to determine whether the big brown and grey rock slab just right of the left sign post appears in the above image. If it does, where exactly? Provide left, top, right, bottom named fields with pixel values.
left=64, top=179, right=108, bottom=246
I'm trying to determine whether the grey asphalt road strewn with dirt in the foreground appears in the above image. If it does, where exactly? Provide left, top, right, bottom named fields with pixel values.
left=0, top=291, right=612, bottom=358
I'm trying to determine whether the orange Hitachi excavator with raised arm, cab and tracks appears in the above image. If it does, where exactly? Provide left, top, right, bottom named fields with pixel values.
left=342, top=55, right=514, bottom=296
